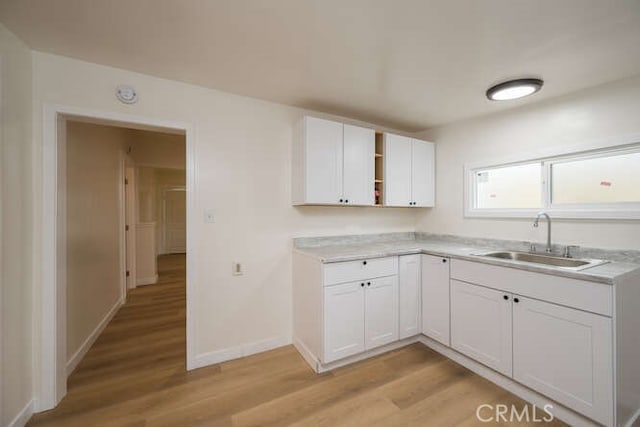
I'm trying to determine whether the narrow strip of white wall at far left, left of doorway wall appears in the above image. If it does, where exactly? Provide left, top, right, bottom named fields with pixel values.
left=0, top=24, right=32, bottom=426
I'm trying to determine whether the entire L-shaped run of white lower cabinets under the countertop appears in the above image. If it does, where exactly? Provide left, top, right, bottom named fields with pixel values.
left=294, top=254, right=640, bottom=426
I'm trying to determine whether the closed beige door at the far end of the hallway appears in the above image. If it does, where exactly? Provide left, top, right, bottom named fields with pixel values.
left=163, top=188, right=187, bottom=253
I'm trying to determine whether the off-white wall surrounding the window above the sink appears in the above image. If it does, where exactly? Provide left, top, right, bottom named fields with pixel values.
left=417, top=78, right=640, bottom=249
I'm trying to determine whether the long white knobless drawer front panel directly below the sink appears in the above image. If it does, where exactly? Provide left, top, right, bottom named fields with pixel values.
left=451, top=259, right=613, bottom=316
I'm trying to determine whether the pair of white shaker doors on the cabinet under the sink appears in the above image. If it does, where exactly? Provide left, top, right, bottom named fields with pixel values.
left=451, top=279, right=614, bottom=425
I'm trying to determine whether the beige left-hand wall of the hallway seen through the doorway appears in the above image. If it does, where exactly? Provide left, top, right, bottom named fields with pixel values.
left=66, top=121, right=128, bottom=361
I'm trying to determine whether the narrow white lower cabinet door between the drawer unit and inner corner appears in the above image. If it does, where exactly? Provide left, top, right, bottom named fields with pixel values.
left=398, top=255, right=421, bottom=339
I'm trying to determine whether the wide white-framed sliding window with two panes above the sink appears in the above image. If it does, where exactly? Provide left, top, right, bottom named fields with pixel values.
left=465, top=144, right=640, bottom=218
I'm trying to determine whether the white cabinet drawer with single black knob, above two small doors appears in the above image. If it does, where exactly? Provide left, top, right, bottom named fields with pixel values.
left=324, top=257, right=398, bottom=286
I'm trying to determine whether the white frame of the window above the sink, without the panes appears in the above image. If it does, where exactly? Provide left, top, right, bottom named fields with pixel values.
left=464, top=141, right=640, bottom=219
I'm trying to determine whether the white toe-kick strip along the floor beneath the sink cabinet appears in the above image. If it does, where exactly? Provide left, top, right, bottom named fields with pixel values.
left=418, top=335, right=599, bottom=427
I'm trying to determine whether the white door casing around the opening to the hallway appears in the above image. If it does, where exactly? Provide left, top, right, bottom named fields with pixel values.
left=37, top=103, right=197, bottom=412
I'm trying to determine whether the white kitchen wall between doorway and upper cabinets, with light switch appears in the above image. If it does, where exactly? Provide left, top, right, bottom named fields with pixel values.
left=33, top=52, right=416, bottom=374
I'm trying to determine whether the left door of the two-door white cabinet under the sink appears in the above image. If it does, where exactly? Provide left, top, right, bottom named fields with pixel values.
left=451, top=280, right=512, bottom=377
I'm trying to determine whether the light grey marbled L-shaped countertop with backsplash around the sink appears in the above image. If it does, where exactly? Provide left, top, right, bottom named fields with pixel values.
left=294, top=233, right=640, bottom=284
